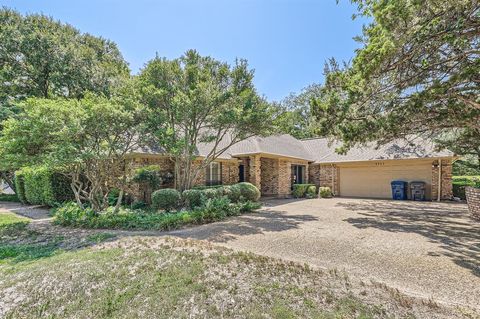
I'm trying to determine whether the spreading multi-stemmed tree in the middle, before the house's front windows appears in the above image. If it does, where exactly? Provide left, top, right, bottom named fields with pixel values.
left=138, top=50, right=273, bottom=190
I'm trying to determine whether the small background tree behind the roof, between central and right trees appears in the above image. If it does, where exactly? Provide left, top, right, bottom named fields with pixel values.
left=274, top=84, right=322, bottom=139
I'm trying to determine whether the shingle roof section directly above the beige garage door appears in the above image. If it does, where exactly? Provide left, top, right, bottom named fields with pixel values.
left=301, top=137, right=454, bottom=163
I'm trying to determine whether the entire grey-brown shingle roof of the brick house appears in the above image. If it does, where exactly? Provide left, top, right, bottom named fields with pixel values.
left=135, top=134, right=454, bottom=163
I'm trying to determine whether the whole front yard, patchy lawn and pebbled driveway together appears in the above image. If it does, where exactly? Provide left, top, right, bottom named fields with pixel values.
left=0, top=199, right=479, bottom=318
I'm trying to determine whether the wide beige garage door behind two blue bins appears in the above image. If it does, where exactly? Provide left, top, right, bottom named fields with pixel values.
left=339, top=163, right=432, bottom=199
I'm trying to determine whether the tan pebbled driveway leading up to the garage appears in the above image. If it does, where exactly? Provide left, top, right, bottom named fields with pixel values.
left=169, top=198, right=480, bottom=309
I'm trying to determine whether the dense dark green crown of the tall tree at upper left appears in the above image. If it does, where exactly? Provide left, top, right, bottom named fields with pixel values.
left=0, top=8, right=129, bottom=106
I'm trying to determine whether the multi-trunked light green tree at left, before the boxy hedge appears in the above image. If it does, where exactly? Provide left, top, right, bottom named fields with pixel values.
left=0, top=95, right=144, bottom=211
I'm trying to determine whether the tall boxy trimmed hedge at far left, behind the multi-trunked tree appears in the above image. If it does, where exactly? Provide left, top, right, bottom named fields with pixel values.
left=15, top=167, right=74, bottom=206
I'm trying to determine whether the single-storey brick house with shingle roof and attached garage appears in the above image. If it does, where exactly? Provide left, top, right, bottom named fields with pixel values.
left=126, top=134, right=456, bottom=200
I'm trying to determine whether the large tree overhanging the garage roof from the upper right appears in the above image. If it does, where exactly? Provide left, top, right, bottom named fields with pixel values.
left=312, top=0, right=480, bottom=152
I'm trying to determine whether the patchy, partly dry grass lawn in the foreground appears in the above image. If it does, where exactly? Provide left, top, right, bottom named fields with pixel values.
left=0, top=222, right=464, bottom=318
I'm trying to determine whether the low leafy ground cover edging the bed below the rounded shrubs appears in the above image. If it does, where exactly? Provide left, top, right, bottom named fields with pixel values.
left=54, top=197, right=260, bottom=230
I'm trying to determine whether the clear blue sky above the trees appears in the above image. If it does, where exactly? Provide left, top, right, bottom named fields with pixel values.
left=0, top=0, right=365, bottom=101
